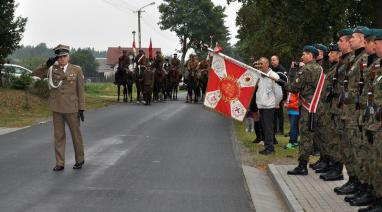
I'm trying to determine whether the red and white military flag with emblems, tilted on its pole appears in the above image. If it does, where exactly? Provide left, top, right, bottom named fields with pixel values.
left=204, top=53, right=260, bottom=121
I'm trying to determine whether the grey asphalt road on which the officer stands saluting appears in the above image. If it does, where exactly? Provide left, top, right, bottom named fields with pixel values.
left=0, top=97, right=252, bottom=212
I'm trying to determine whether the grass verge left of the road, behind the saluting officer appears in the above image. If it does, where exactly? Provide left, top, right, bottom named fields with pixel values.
left=0, top=83, right=117, bottom=127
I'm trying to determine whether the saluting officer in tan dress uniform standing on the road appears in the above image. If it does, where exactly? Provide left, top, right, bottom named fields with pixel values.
left=33, top=44, right=85, bottom=171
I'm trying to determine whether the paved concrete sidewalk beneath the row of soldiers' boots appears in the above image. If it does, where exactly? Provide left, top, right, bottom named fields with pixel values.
left=268, top=164, right=359, bottom=212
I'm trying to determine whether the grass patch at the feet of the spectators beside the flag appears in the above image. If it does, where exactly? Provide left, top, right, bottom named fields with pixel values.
left=234, top=116, right=298, bottom=170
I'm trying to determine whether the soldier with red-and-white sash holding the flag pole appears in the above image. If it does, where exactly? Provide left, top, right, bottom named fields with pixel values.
left=277, top=45, right=323, bottom=175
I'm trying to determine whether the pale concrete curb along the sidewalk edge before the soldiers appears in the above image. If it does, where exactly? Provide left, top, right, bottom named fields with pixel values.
left=268, top=164, right=305, bottom=212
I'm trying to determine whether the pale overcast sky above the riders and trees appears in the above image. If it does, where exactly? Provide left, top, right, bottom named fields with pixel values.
left=16, top=0, right=240, bottom=54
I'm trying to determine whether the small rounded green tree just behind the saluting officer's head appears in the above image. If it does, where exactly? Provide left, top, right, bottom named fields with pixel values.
left=70, top=49, right=98, bottom=77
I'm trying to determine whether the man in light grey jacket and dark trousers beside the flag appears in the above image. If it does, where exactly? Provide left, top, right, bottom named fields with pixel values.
left=256, top=57, right=282, bottom=155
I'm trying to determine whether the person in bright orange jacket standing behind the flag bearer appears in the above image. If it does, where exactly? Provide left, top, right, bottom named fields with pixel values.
left=285, top=93, right=300, bottom=149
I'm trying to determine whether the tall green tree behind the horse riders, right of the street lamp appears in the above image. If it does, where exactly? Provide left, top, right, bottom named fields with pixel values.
left=159, top=0, right=229, bottom=69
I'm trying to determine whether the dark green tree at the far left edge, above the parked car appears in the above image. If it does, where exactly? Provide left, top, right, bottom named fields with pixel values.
left=0, top=0, right=27, bottom=86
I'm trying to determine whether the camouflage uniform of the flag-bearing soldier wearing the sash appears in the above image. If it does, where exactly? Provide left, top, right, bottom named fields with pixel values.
left=285, top=61, right=322, bottom=161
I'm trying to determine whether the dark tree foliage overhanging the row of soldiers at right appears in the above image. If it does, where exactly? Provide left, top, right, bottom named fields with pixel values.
left=228, top=0, right=382, bottom=64
